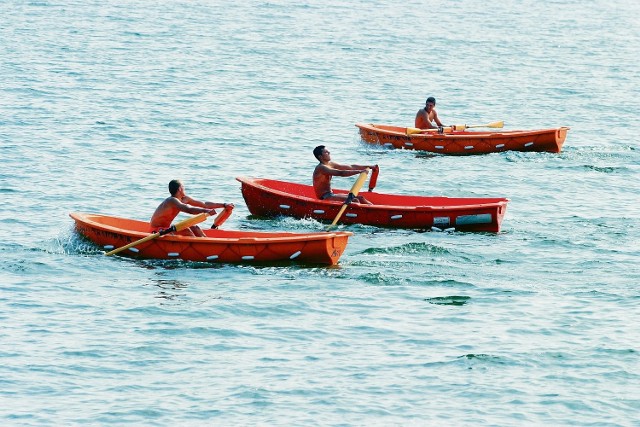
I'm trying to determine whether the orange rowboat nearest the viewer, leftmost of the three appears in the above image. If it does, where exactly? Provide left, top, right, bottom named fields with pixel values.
left=69, top=213, right=353, bottom=265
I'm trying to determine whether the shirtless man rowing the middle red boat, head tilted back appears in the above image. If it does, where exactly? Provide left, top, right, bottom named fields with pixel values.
left=313, top=145, right=378, bottom=205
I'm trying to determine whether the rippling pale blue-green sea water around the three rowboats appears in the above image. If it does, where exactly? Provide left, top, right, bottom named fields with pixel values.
left=0, top=0, right=640, bottom=426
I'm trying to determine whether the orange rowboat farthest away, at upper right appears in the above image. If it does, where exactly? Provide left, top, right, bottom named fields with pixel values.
left=356, top=123, right=569, bottom=155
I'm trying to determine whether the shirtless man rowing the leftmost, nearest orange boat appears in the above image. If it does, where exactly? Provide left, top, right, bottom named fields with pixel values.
left=149, top=179, right=233, bottom=237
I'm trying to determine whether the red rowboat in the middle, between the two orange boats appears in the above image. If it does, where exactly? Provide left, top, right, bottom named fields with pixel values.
left=236, top=177, right=509, bottom=233
